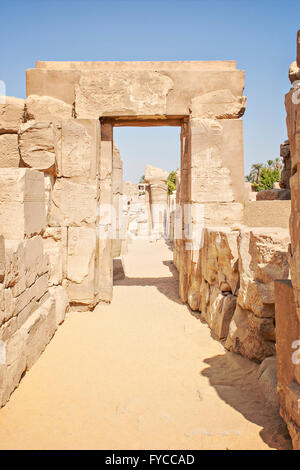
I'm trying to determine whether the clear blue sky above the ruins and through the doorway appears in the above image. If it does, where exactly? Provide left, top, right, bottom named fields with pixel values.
left=0, top=0, right=300, bottom=180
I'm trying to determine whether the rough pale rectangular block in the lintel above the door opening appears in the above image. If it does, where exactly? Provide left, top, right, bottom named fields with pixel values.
left=75, top=71, right=173, bottom=119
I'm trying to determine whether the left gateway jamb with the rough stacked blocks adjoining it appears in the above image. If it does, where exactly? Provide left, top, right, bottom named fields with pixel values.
left=0, top=95, right=112, bottom=308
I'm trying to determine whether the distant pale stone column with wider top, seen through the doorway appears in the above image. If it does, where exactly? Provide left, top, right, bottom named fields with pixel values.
left=145, top=165, right=168, bottom=238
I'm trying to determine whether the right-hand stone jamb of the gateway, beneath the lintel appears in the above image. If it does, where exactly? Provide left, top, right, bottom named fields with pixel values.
left=184, top=93, right=246, bottom=301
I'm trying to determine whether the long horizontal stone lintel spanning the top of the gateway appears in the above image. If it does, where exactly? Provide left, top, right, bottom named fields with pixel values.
left=27, top=61, right=245, bottom=118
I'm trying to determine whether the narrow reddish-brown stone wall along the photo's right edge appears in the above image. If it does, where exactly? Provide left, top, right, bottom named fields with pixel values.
left=275, top=31, right=300, bottom=450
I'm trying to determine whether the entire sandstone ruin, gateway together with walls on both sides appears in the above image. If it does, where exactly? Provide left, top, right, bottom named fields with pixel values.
left=0, top=47, right=300, bottom=448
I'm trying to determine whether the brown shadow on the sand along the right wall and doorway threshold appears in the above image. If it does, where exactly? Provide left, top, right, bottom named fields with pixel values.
left=113, top=246, right=291, bottom=450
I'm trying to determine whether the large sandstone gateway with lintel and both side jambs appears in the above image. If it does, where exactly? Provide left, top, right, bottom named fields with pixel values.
left=26, top=61, right=245, bottom=308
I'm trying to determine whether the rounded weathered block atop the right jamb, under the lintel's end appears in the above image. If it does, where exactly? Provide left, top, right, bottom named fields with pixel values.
left=191, top=89, right=246, bottom=119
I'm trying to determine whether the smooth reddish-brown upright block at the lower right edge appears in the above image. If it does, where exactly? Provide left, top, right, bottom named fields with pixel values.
left=275, top=280, right=300, bottom=450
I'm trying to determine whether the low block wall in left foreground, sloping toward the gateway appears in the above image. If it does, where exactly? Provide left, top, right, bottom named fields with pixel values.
left=0, top=168, right=68, bottom=407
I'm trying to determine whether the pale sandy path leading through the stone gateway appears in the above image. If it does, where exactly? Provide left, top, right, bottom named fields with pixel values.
left=0, top=242, right=288, bottom=449
